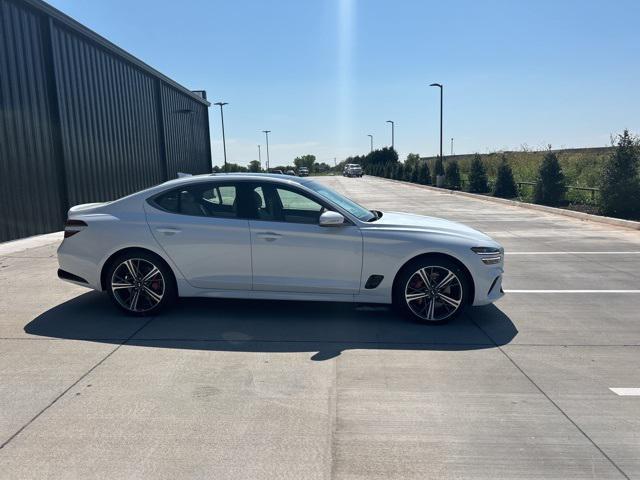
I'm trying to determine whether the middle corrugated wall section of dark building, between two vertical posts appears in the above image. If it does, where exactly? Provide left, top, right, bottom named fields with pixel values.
left=53, top=25, right=164, bottom=205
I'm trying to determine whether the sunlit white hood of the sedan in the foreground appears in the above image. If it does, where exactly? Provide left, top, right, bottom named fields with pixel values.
left=364, top=212, right=495, bottom=243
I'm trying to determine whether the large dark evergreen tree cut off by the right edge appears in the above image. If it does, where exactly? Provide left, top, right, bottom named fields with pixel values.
left=600, top=130, right=640, bottom=219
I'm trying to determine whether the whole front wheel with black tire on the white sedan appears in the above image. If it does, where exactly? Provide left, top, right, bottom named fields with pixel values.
left=393, top=255, right=471, bottom=324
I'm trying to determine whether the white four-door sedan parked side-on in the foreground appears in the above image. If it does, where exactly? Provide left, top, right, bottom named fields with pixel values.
left=58, top=174, right=503, bottom=323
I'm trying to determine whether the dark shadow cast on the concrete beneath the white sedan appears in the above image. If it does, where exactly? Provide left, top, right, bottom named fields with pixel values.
left=24, top=292, right=518, bottom=360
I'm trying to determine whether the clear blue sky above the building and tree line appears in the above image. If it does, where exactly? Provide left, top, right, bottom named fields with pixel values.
left=49, top=0, right=640, bottom=166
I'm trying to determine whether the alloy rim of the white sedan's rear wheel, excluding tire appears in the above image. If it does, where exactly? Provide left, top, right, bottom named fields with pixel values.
left=111, top=258, right=165, bottom=313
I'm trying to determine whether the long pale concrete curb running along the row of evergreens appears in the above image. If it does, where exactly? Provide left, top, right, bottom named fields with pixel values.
left=369, top=175, right=640, bottom=230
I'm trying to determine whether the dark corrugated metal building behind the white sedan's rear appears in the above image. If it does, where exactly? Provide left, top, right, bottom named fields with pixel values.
left=0, top=0, right=211, bottom=241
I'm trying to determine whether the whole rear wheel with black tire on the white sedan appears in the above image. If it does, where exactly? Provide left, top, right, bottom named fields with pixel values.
left=105, top=250, right=178, bottom=316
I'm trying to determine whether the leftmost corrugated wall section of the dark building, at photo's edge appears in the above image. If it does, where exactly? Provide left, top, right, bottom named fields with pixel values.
left=0, top=0, right=62, bottom=241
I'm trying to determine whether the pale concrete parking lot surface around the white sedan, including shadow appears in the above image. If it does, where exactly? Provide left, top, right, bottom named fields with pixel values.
left=0, top=177, right=640, bottom=479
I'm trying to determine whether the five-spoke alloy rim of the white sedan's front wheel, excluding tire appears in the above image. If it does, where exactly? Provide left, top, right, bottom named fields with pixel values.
left=404, top=266, right=463, bottom=322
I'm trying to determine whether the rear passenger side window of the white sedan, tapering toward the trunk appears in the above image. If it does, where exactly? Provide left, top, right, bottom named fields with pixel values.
left=151, top=184, right=238, bottom=218
